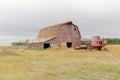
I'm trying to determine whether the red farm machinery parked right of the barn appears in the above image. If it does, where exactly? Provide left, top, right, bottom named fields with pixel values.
left=74, top=36, right=107, bottom=51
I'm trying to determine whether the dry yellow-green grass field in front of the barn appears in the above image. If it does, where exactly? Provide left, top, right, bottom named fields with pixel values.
left=0, top=45, right=120, bottom=80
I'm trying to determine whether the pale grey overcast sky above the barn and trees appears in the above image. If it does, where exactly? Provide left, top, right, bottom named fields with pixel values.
left=0, top=0, right=120, bottom=44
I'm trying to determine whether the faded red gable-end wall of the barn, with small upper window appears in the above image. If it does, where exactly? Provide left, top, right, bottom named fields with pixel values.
left=58, top=24, right=81, bottom=47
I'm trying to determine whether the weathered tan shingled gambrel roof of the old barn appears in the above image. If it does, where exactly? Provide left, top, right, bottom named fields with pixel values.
left=29, top=21, right=74, bottom=43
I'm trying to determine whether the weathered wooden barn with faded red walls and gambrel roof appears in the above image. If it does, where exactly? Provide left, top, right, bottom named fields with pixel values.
left=27, top=21, right=81, bottom=48
